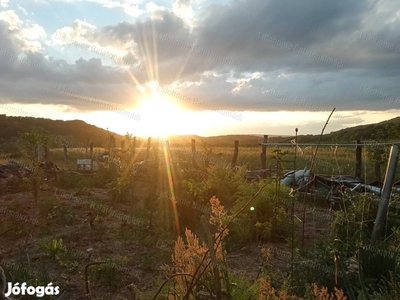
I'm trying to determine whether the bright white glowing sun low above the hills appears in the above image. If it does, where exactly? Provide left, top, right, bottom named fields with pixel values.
left=137, top=93, right=184, bottom=137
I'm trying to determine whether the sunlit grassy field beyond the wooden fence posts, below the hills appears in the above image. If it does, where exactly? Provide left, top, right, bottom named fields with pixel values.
left=14, top=144, right=390, bottom=181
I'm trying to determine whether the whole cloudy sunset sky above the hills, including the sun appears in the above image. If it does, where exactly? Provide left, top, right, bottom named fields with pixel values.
left=0, top=0, right=400, bottom=136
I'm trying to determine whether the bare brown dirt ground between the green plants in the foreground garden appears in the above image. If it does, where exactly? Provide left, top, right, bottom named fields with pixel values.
left=0, top=188, right=329, bottom=300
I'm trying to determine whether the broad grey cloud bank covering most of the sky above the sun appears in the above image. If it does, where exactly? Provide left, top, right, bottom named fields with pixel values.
left=0, top=0, right=400, bottom=117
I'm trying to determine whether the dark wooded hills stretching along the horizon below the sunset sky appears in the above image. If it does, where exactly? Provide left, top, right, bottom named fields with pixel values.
left=0, top=115, right=400, bottom=152
